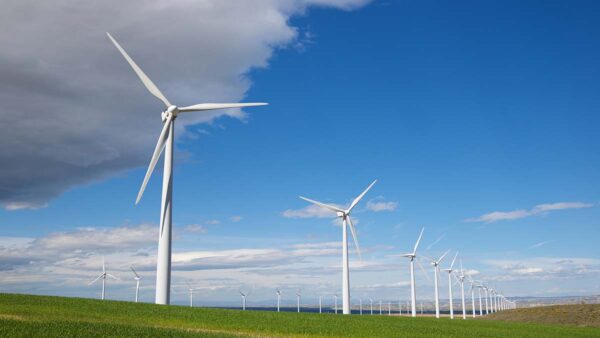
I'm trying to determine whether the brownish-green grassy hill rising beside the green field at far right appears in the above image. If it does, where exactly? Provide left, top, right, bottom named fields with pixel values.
left=486, top=304, right=600, bottom=328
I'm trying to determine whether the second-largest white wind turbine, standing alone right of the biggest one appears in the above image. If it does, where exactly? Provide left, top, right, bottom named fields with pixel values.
left=300, top=180, right=377, bottom=315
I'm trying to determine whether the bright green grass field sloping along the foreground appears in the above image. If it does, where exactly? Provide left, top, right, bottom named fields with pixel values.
left=0, top=294, right=600, bottom=337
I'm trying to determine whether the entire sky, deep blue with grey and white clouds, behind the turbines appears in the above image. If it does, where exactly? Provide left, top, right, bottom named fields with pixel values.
left=0, top=0, right=600, bottom=305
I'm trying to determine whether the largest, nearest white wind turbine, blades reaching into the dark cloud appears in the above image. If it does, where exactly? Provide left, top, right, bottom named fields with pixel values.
left=106, top=33, right=266, bottom=304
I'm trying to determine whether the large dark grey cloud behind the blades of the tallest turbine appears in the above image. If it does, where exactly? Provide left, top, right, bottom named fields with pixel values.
left=0, top=0, right=369, bottom=210
